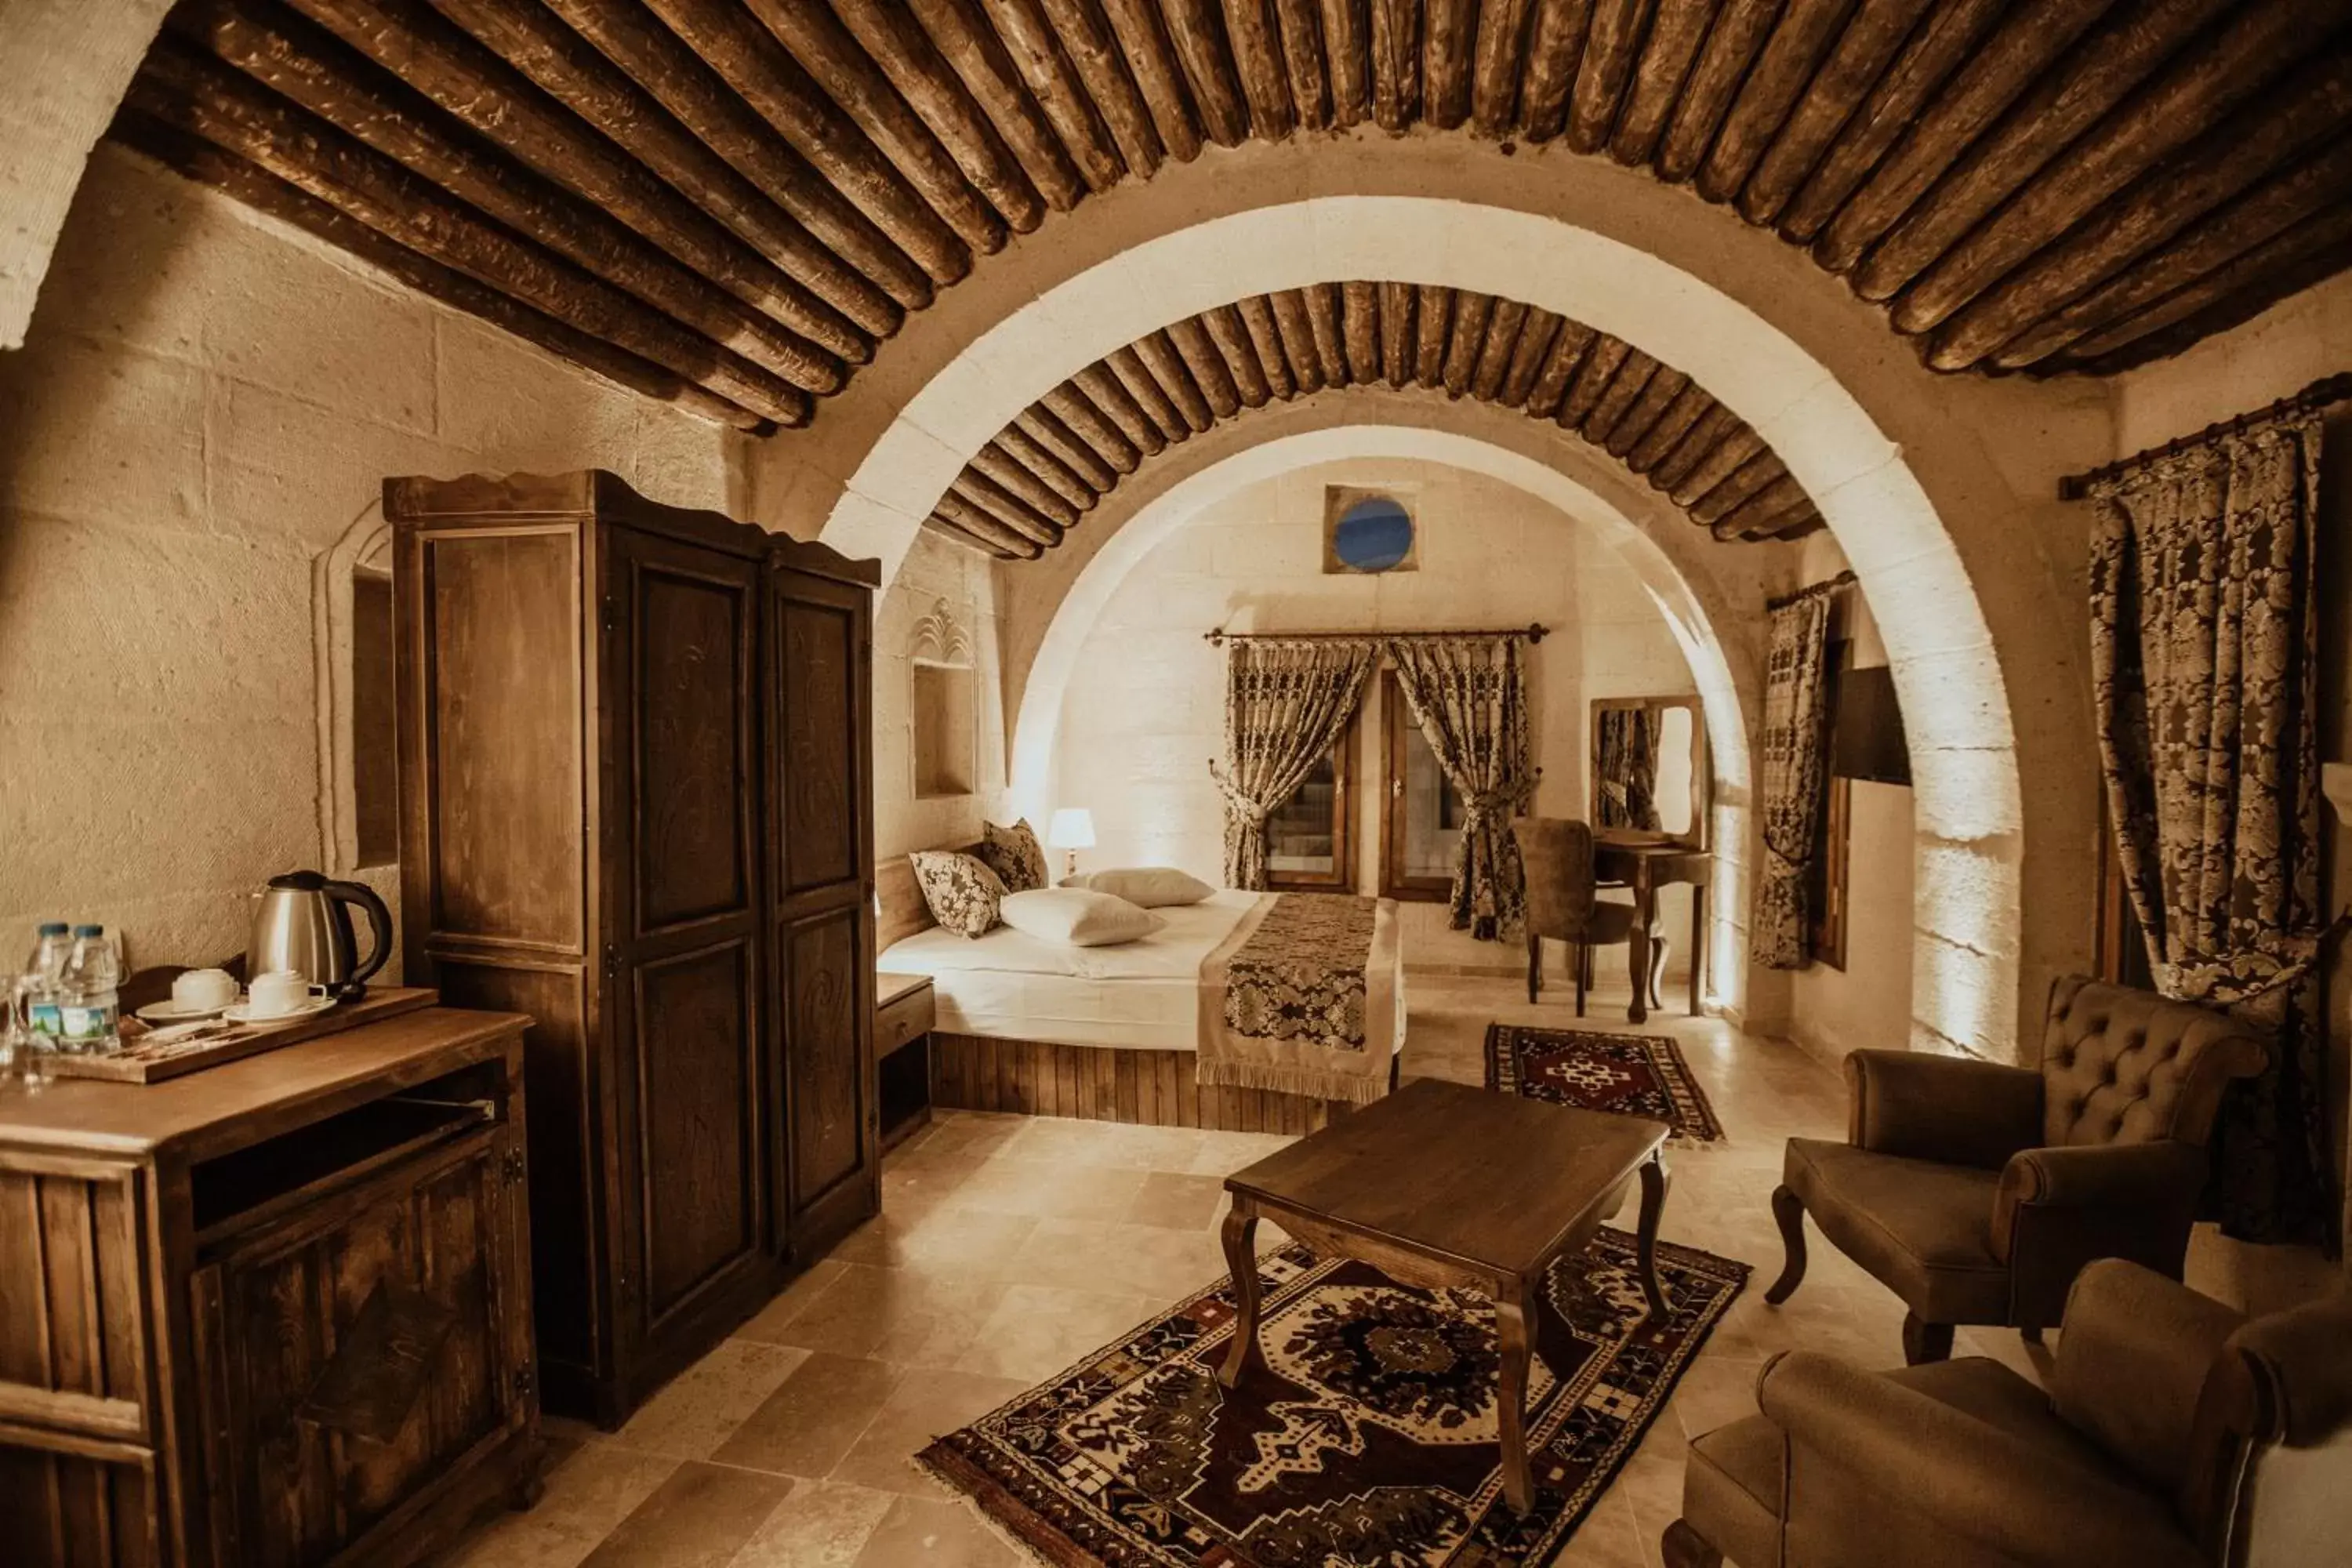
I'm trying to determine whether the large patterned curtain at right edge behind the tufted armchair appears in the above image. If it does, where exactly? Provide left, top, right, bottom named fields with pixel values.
left=2091, top=419, right=2333, bottom=1241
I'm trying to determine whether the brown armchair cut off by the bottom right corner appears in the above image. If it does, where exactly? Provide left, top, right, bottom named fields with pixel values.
left=1661, top=1258, right=2352, bottom=1568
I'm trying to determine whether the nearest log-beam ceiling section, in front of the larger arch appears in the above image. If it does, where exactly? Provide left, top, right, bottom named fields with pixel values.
left=115, top=0, right=2352, bottom=430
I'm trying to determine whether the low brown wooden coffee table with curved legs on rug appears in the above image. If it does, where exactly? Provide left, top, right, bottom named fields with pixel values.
left=1216, top=1079, right=1672, bottom=1514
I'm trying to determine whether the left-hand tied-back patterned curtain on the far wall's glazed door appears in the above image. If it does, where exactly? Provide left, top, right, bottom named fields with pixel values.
left=1209, top=640, right=1381, bottom=888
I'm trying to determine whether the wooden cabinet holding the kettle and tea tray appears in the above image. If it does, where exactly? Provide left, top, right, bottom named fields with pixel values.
left=0, top=1008, right=541, bottom=1568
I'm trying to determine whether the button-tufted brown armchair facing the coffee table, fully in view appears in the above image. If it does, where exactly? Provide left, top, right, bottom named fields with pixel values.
left=1764, top=975, right=2270, bottom=1366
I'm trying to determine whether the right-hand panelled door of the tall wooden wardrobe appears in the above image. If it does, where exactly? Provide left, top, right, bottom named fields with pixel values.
left=767, top=557, right=880, bottom=1258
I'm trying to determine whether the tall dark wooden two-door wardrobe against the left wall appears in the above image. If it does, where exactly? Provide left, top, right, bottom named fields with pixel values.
left=383, top=470, right=880, bottom=1427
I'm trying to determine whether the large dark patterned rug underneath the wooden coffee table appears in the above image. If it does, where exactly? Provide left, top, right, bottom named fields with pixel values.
left=917, top=1229, right=1748, bottom=1568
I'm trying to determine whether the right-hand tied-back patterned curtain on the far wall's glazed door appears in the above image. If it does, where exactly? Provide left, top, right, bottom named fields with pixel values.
left=1388, top=637, right=1536, bottom=942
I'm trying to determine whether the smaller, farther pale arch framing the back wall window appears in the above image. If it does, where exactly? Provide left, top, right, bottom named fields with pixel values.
left=1009, top=423, right=1750, bottom=1008
